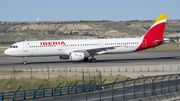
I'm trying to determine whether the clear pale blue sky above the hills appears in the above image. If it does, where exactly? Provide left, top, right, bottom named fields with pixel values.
left=0, top=0, right=180, bottom=22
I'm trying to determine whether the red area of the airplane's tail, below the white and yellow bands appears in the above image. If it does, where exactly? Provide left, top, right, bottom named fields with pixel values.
left=135, top=22, right=166, bottom=52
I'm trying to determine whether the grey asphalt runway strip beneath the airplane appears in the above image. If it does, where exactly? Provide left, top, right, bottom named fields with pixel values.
left=0, top=50, right=180, bottom=70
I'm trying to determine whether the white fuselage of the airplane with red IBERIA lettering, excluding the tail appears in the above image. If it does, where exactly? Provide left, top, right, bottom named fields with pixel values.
left=4, top=37, right=143, bottom=57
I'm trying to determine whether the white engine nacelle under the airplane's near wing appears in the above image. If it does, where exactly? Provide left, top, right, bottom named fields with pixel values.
left=69, top=52, right=84, bottom=61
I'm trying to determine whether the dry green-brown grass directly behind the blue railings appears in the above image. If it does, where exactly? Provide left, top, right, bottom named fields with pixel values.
left=0, top=71, right=127, bottom=92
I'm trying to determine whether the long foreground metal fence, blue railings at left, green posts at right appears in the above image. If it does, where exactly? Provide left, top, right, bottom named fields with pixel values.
left=0, top=74, right=180, bottom=101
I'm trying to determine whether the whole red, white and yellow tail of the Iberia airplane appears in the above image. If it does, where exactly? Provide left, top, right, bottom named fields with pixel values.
left=135, top=14, right=168, bottom=51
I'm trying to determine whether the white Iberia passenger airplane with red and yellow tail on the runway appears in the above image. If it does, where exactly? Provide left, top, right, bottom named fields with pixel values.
left=4, top=14, right=170, bottom=65
